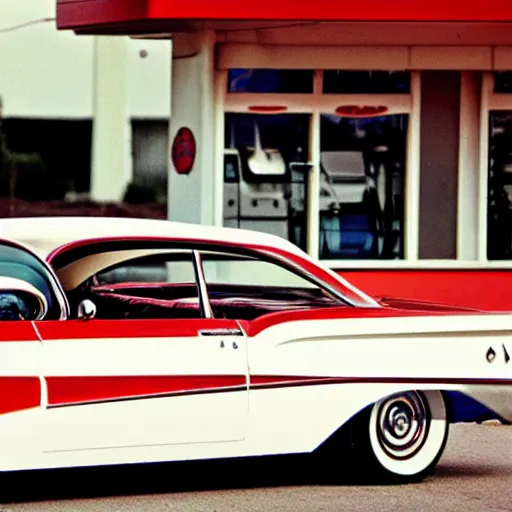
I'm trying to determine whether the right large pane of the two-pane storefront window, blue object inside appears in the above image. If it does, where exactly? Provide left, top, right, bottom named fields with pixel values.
left=320, top=115, right=408, bottom=259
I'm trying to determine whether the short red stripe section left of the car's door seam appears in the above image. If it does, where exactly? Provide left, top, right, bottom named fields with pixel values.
left=0, top=377, right=41, bottom=414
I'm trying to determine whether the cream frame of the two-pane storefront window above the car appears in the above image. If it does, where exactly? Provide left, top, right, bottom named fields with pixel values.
left=218, top=69, right=421, bottom=269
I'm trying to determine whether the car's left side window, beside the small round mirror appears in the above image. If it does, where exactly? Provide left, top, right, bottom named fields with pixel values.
left=85, top=251, right=201, bottom=319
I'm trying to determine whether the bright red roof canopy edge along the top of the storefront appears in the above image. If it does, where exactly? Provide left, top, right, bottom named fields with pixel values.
left=57, top=0, right=512, bottom=34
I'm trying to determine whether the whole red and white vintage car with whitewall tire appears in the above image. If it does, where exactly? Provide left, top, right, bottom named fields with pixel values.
left=0, top=217, right=512, bottom=481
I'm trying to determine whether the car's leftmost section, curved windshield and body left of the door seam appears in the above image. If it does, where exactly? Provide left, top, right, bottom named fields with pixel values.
left=0, top=240, right=72, bottom=469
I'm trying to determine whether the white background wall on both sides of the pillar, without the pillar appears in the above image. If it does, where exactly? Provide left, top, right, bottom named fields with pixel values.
left=0, top=0, right=171, bottom=119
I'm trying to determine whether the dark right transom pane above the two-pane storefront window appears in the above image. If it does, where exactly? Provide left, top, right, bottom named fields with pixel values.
left=323, top=71, right=411, bottom=94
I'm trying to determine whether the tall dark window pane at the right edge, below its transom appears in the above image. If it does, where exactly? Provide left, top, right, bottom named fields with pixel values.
left=487, top=111, right=512, bottom=260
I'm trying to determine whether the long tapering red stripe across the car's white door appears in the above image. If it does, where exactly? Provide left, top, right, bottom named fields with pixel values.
left=46, top=375, right=246, bottom=405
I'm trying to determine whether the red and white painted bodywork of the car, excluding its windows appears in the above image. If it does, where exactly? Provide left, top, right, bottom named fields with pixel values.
left=0, top=218, right=512, bottom=476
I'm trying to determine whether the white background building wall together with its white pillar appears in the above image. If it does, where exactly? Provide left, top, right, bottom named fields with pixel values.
left=0, top=0, right=172, bottom=201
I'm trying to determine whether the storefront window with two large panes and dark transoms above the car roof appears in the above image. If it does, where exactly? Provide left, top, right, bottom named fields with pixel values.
left=223, top=69, right=414, bottom=261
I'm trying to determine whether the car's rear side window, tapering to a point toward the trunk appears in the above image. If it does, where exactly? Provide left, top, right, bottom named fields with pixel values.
left=201, top=251, right=345, bottom=320
